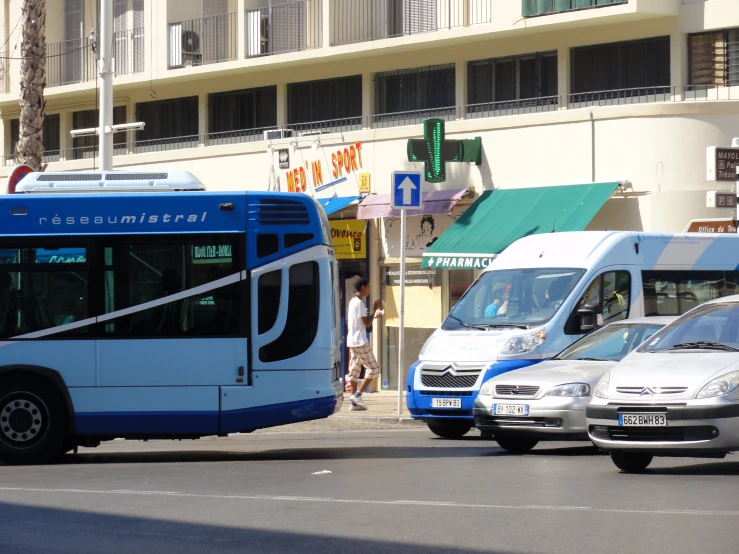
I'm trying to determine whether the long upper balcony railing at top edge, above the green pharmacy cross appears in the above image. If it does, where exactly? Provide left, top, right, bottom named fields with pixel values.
left=330, top=0, right=493, bottom=46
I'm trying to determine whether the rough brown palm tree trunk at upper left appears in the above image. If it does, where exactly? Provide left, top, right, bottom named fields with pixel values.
left=17, top=0, right=46, bottom=171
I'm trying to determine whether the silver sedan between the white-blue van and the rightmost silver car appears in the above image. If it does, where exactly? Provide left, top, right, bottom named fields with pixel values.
left=473, top=317, right=675, bottom=453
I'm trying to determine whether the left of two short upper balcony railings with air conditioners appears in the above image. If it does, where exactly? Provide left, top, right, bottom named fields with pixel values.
left=169, top=13, right=238, bottom=69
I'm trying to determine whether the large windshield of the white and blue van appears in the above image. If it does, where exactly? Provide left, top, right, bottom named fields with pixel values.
left=442, top=268, right=585, bottom=330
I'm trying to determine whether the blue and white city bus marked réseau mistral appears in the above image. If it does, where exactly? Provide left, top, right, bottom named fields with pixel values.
left=0, top=171, right=343, bottom=463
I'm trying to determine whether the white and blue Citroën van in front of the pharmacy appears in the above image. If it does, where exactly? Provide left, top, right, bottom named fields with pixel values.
left=406, top=231, right=739, bottom=438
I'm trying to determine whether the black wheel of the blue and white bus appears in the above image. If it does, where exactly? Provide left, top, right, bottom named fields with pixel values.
left=0, top=375, right=70, bottom=464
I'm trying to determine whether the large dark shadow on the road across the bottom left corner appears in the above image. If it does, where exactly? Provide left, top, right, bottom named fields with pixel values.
left=0, top=502, right=524, bottom=554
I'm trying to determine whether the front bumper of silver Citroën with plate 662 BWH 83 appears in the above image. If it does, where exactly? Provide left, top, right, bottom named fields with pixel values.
left=586, top=399, right=739, bottom=456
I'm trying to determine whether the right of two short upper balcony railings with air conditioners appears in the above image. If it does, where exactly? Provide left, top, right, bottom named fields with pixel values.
left=245, top=0, right=323, bottom=58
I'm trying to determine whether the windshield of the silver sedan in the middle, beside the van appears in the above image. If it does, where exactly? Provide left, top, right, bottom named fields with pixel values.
left=554, top=323, right=664, bottom=362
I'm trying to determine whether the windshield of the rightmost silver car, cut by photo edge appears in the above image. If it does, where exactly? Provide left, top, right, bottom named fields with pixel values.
left=638, top=302, right=739, bottom=352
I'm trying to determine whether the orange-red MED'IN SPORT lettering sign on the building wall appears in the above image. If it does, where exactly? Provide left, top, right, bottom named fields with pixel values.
left=285, top=142, right=364, bottom=192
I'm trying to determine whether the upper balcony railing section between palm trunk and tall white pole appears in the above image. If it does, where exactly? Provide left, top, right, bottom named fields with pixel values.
left=46, top=38, right=97, bottom=87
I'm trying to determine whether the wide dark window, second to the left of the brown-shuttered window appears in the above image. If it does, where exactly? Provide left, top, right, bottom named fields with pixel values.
left=467, top=52, right=557, bottom=105
